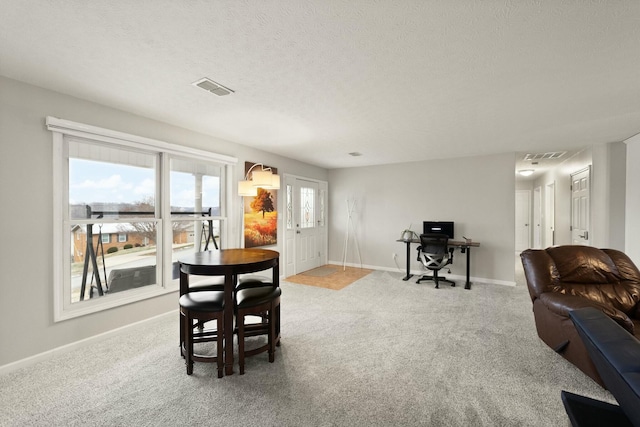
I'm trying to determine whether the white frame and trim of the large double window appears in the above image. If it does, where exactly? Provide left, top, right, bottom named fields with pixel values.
left=46, top=116, right=238, bottom=322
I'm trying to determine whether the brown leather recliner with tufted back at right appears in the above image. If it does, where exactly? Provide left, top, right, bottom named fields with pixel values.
left=520, top=246, right=640, bottom=387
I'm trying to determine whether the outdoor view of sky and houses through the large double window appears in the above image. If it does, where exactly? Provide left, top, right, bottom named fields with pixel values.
left=69, top=159, right=221, bottom=303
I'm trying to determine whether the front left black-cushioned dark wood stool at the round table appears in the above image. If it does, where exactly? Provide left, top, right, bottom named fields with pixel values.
left=179, top=291, right=224, bottom=378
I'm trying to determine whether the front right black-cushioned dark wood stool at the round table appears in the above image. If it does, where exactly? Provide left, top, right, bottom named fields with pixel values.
left=235, top=282, right=282, bottom=375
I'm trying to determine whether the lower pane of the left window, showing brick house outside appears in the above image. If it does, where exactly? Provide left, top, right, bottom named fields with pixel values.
left=70, top=221, right=158, bottom=303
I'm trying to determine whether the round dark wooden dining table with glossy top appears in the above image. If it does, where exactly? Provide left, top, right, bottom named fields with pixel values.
left=178, top=248, right=280, bottom=375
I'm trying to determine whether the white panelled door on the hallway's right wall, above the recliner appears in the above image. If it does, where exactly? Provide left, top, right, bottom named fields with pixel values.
left=571, top=166, right=591, bottom=245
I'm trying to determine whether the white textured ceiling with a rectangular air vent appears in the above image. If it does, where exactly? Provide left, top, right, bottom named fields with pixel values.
left=0, top=0, right=640, bottom=168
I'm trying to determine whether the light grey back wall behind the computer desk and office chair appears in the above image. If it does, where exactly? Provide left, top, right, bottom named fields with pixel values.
left=329, top=154, right=515, bottom=283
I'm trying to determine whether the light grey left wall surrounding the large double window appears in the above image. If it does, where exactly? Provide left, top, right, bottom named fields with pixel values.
left=0, top=77, right=327, bottom=366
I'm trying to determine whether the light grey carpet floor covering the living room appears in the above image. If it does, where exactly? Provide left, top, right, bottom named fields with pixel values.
left=0, top=271, right=611, bottom=427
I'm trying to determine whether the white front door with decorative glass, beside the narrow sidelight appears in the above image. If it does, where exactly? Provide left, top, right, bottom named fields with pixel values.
left=293, top=178, right=322, bottom=274
